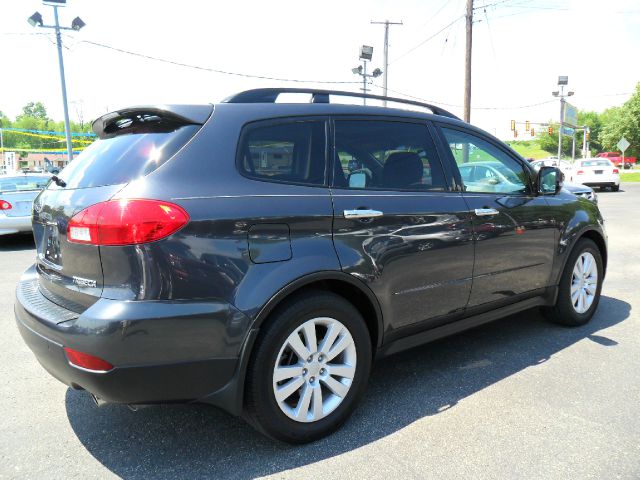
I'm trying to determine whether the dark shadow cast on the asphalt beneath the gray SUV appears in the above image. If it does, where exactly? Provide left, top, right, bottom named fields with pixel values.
left=66, top=297, right=631, bottom=479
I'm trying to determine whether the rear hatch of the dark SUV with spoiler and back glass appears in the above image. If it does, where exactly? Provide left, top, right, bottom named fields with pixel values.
left=33, top=106, right=212, bottom=313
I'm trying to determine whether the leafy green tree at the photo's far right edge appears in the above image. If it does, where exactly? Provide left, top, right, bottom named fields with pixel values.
left=601, top=83, right=640, bottom=157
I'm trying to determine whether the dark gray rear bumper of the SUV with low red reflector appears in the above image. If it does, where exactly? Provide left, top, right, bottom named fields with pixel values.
left=15, top=271, right=247, bottom=413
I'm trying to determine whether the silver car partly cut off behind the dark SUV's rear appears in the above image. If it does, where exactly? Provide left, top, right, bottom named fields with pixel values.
left=0, top=173, right=51, bottom=235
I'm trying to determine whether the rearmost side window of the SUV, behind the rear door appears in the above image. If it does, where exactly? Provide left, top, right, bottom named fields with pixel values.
left=238, top=120, right=325, bottom=185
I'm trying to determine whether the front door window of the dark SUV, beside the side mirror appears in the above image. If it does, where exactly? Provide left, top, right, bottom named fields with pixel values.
left=442, top=128, right=528, bottom=193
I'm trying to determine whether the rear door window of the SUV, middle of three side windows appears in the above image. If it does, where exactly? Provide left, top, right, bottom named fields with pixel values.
left=333, top=120, right=446, bottom=191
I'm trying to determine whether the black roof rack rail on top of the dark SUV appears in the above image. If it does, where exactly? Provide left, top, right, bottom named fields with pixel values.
left=222, top=88, right=460, bottom=120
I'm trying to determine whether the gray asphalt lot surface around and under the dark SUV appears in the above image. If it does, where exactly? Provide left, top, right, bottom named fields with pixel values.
left=0, top=184, right=640, bottom=478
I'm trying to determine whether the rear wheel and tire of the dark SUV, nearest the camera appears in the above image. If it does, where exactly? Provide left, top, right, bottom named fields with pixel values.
left=245, top=290, right=372, bottom=444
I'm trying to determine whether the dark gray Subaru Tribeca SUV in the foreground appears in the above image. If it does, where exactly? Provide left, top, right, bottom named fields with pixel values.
left=15, top=89, right=607, bottom=443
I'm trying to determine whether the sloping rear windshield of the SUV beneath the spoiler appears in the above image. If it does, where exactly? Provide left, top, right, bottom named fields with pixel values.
left=58, top=125, right=201, bottom=188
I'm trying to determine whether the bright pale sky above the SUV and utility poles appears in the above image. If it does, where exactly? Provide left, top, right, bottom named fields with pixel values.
left=0, top=0, right=640, bottom=139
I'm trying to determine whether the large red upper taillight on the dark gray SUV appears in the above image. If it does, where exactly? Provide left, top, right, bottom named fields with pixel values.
left=67, top=199, right=189, bottom=245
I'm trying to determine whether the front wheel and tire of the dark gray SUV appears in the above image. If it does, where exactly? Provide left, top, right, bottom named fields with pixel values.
left=543, top=238, right=604, bottom=327
